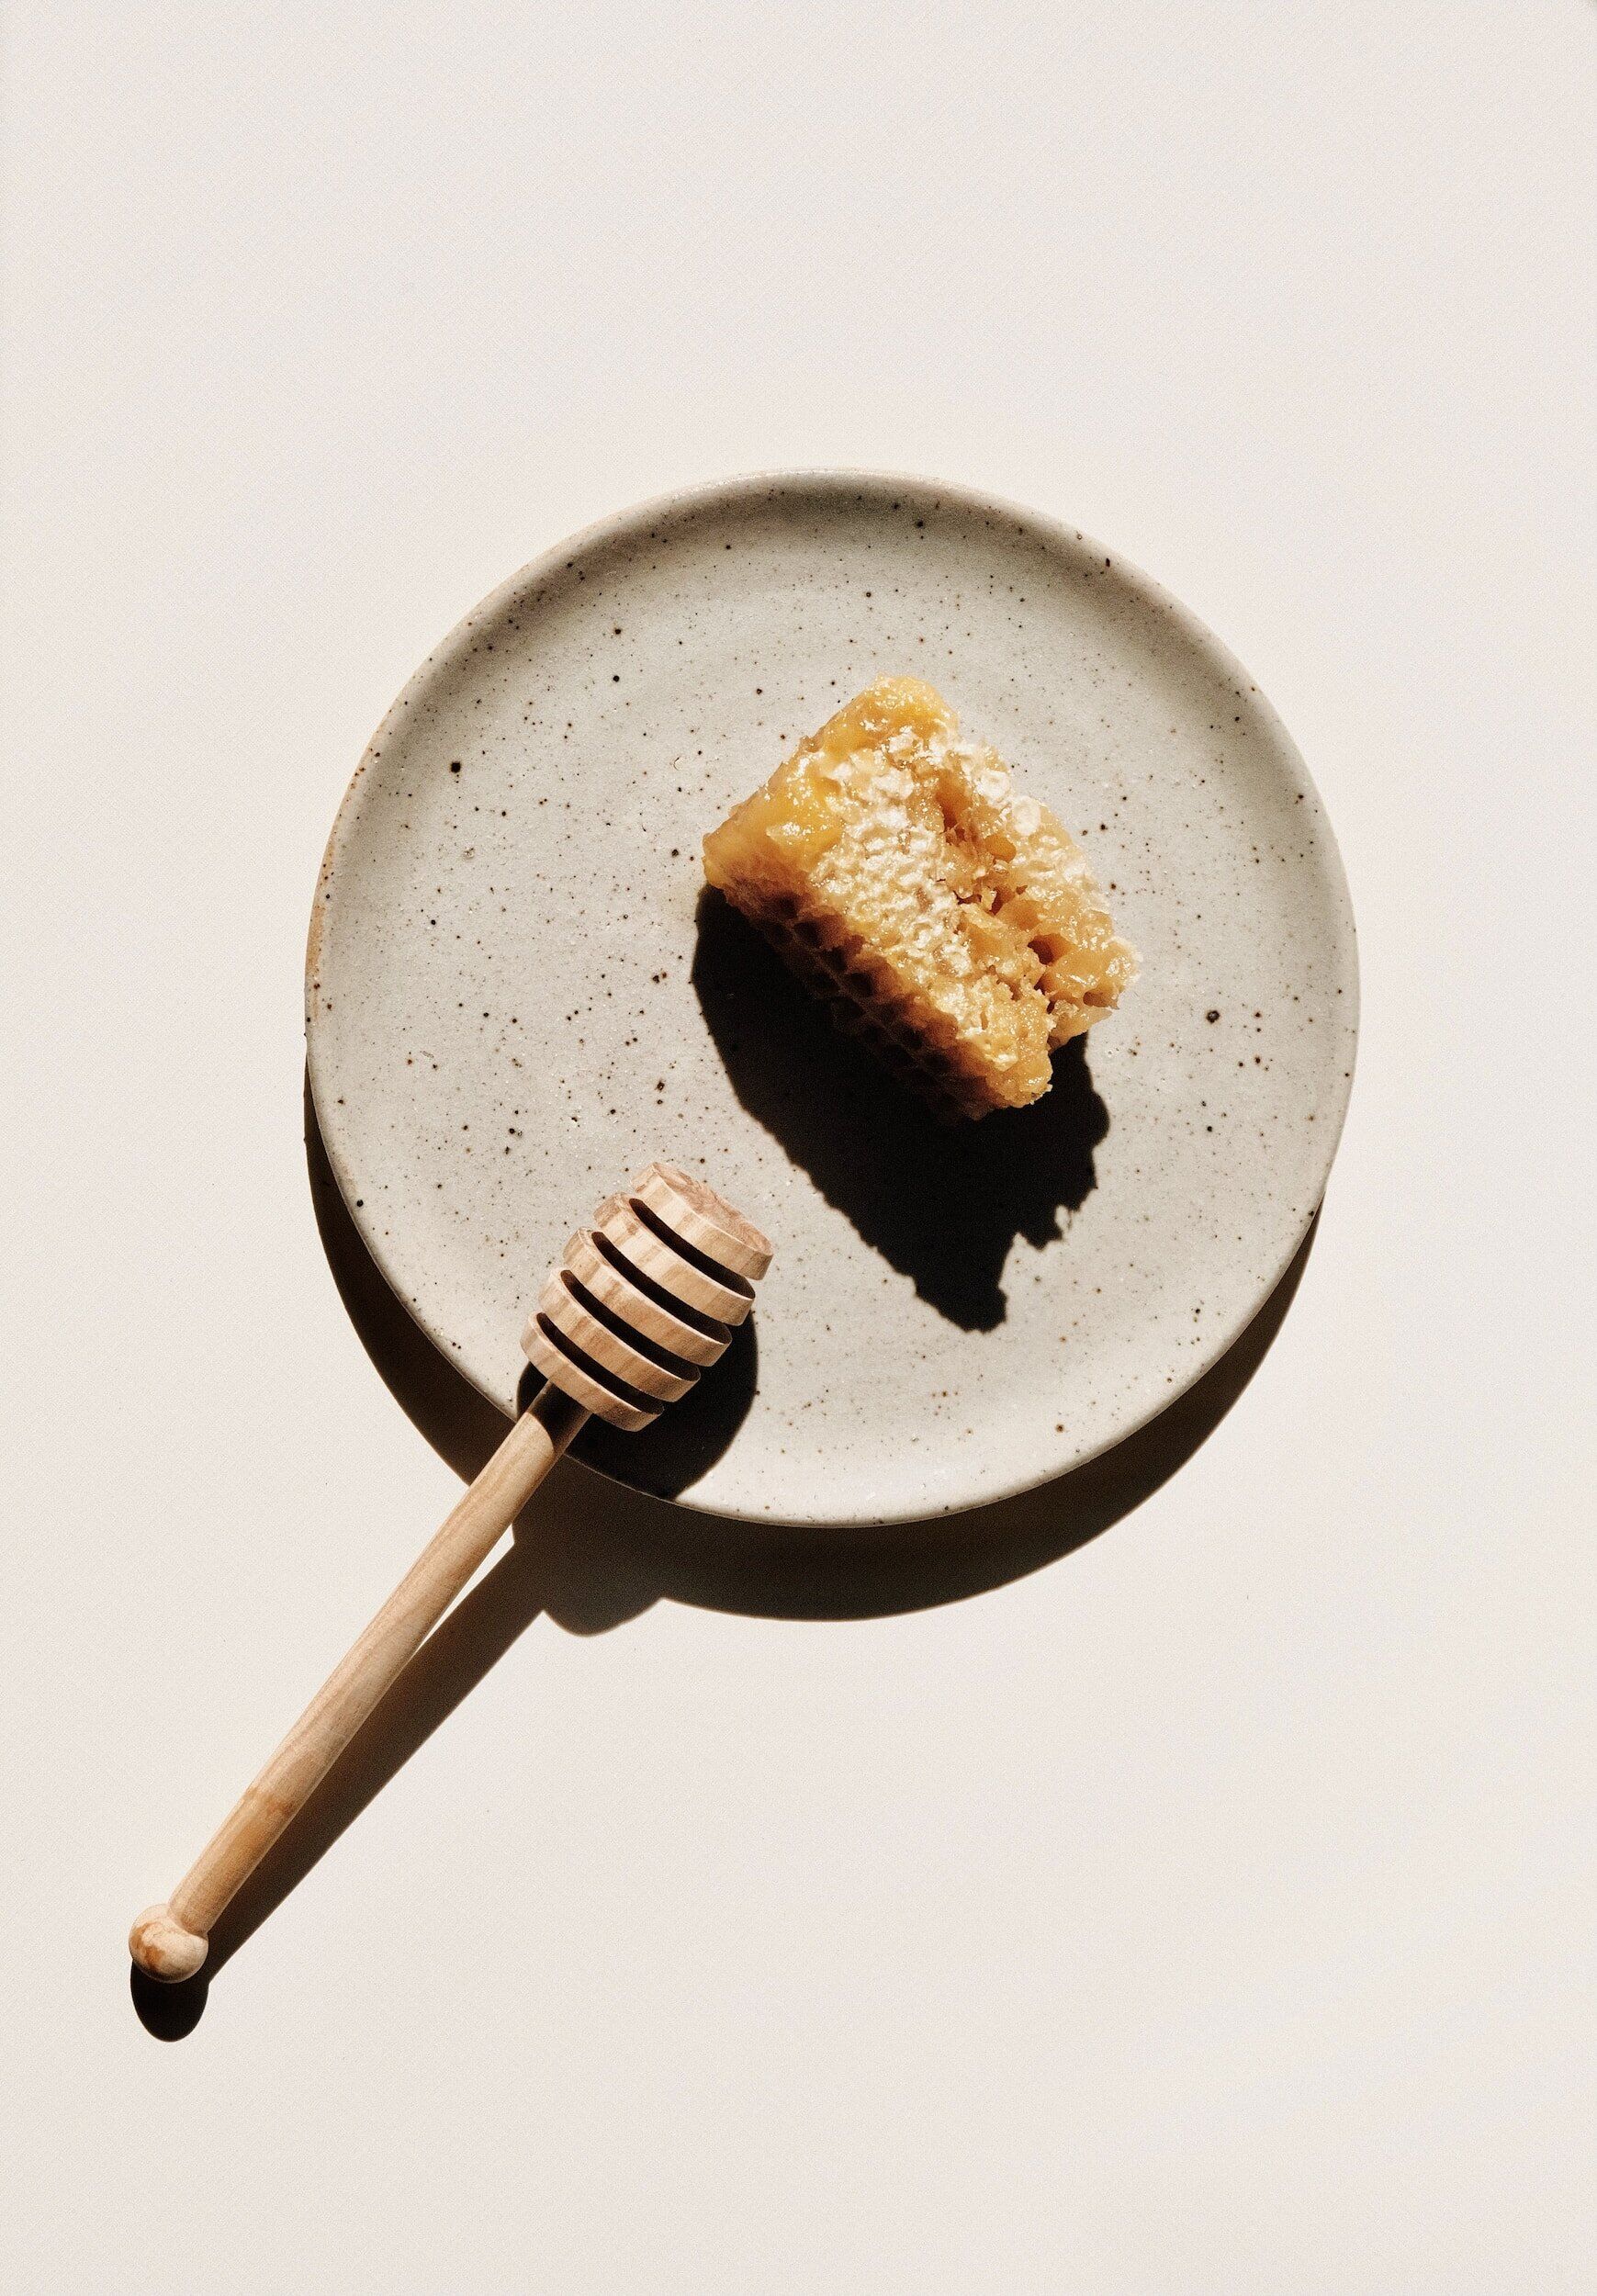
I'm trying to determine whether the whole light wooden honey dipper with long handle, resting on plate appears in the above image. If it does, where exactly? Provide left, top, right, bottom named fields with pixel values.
left=129, top=1165, right=771, bottom=1984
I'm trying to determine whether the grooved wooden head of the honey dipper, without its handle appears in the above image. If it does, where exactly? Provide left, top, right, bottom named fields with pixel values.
left=521, top=1165, right=771, bottom=1431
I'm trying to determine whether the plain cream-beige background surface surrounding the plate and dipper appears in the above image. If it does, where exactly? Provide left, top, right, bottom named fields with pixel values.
left=0, top=0, right=1597, bottom=2296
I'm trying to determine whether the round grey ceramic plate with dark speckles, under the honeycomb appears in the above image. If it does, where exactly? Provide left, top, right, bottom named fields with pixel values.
left=308, top=473, right=1356, bottom=1525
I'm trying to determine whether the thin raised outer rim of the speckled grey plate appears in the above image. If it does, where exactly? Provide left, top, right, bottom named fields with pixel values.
left=303, top=467, right=1361, bottom=1532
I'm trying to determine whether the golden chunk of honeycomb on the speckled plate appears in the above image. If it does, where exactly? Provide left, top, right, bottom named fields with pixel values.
left=704, top=678, right=1136, bottom=1116
